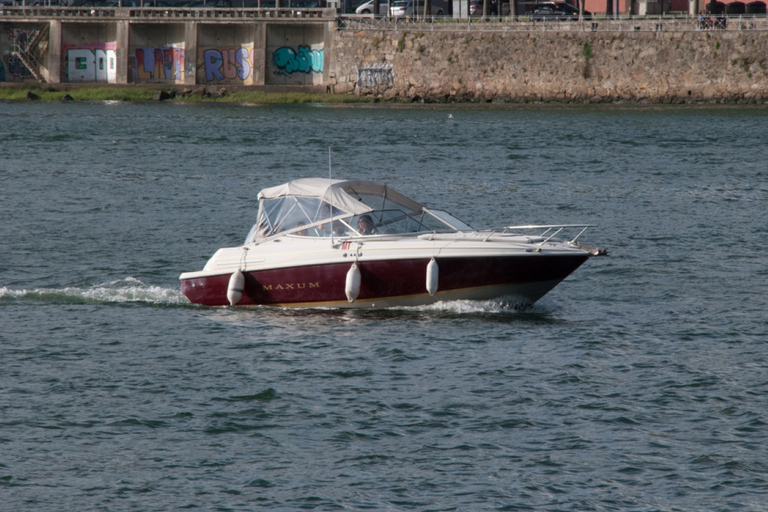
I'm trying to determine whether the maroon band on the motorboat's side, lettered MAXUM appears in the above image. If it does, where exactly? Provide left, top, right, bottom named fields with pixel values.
left=181, top=254, right=589, bottom=306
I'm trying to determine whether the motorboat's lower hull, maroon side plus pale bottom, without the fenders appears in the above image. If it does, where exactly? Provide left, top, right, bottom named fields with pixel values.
left=181, top=251, right=589, bottom=308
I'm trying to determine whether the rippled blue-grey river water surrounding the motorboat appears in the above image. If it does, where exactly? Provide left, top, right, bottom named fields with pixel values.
left=0, top=103, right=768, bottom=511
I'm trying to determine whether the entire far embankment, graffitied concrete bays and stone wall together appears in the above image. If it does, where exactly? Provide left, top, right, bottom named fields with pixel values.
left=0, top=9, right=768, bottom=104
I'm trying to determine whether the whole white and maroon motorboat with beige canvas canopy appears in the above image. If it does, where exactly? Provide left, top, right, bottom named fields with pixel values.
left=180, top=178, right=605, bottom=308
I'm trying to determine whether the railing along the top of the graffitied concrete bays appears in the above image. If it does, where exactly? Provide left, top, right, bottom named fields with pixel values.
left=0, top=6, right=337, bottom=20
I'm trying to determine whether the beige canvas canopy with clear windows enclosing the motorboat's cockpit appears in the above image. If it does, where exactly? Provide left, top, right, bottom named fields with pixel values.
left=245, top=178, right=471, bottom=244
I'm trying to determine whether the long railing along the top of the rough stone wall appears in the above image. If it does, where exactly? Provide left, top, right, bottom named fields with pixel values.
left=338, top=15, right=768, bottom=32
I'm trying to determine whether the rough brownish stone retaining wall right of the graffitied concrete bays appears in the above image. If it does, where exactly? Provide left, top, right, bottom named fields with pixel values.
left=328, top=30, right=768, bottom=103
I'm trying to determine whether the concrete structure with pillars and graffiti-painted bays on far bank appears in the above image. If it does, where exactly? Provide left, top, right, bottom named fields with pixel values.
left=0, top=7, right=337, bottom=89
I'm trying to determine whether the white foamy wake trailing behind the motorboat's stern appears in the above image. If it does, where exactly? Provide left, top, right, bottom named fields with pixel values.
left=0, top=277, right=189, bottom=305
